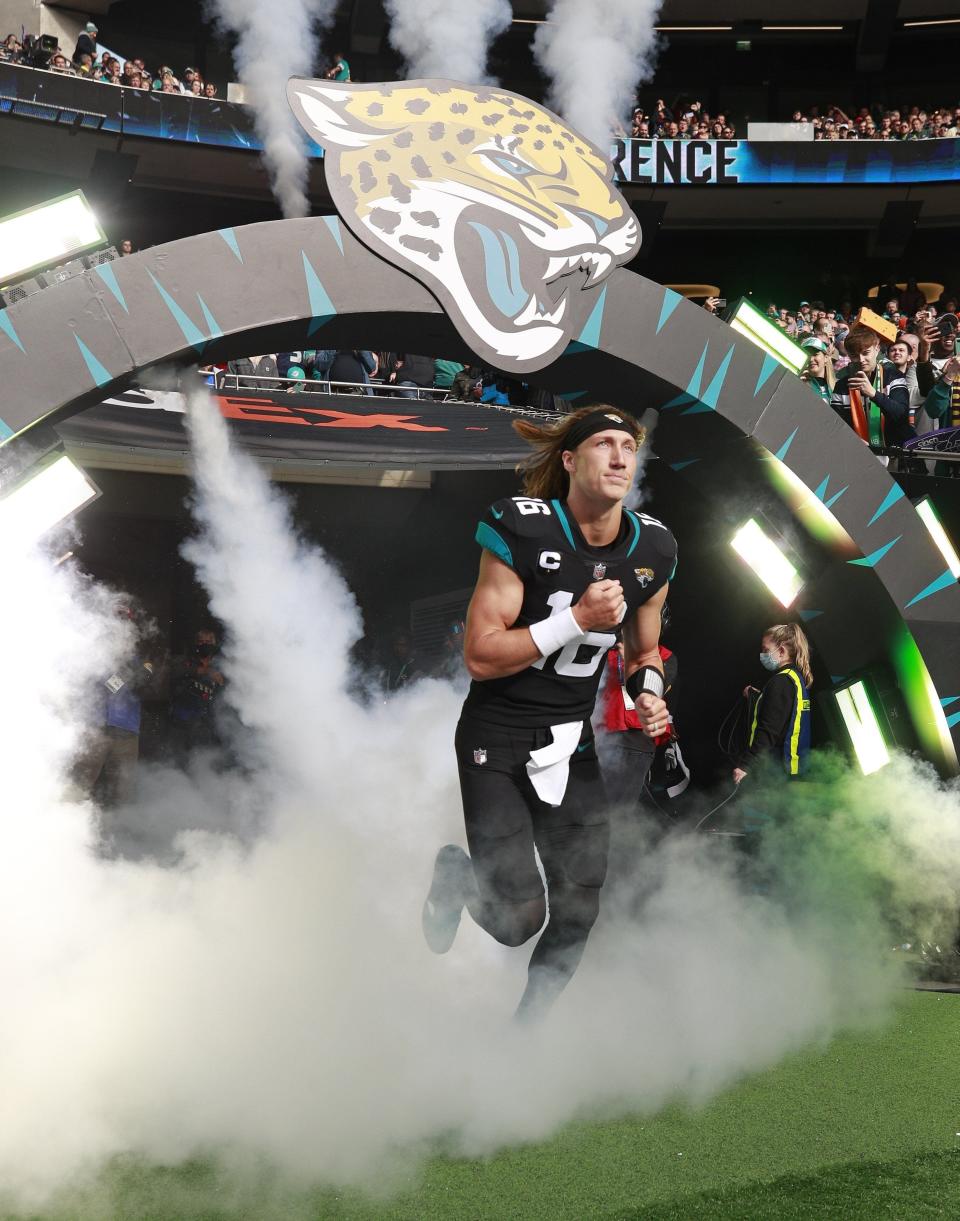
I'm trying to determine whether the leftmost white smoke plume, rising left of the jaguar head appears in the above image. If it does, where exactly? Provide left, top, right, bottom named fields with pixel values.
left=208, top=0, right=336, bottom=217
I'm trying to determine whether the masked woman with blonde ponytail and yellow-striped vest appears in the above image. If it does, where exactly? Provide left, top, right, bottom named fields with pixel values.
left=733, top=623, right=813, bottom=784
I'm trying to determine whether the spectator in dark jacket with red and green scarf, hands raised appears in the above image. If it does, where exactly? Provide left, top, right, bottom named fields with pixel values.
left=831, top=326, right=914, bottom=448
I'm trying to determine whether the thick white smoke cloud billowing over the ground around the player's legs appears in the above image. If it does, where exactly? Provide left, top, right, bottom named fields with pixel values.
left=0, top=397, right=960, bottom=1216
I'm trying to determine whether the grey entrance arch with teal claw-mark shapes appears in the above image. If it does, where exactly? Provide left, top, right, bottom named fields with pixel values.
left=0, top=217, right=960, bottom=773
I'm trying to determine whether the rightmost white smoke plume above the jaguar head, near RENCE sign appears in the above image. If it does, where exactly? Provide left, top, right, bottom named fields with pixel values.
left=534, top=0, right=661, bottom=149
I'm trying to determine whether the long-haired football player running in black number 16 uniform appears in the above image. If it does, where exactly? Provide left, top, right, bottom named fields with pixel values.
left=423, top=405, right=677, bottom=1017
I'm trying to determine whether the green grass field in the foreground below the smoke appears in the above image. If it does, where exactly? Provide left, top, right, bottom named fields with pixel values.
left=18, top=993, right=960, bottom=1221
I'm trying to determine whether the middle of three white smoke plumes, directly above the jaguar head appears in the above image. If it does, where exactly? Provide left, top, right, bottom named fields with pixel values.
left=385, top=0, right=513, bottom=84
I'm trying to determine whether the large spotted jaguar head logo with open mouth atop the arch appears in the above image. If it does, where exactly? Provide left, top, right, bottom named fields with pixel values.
left=287, top=77, right=640, bottom=372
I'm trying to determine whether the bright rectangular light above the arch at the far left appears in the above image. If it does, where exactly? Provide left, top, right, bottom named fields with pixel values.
left=0, top=190, right=106, bottom=284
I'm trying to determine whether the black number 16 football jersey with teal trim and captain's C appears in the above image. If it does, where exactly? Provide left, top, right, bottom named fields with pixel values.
left=464, top=496, right=677, bottom=726
